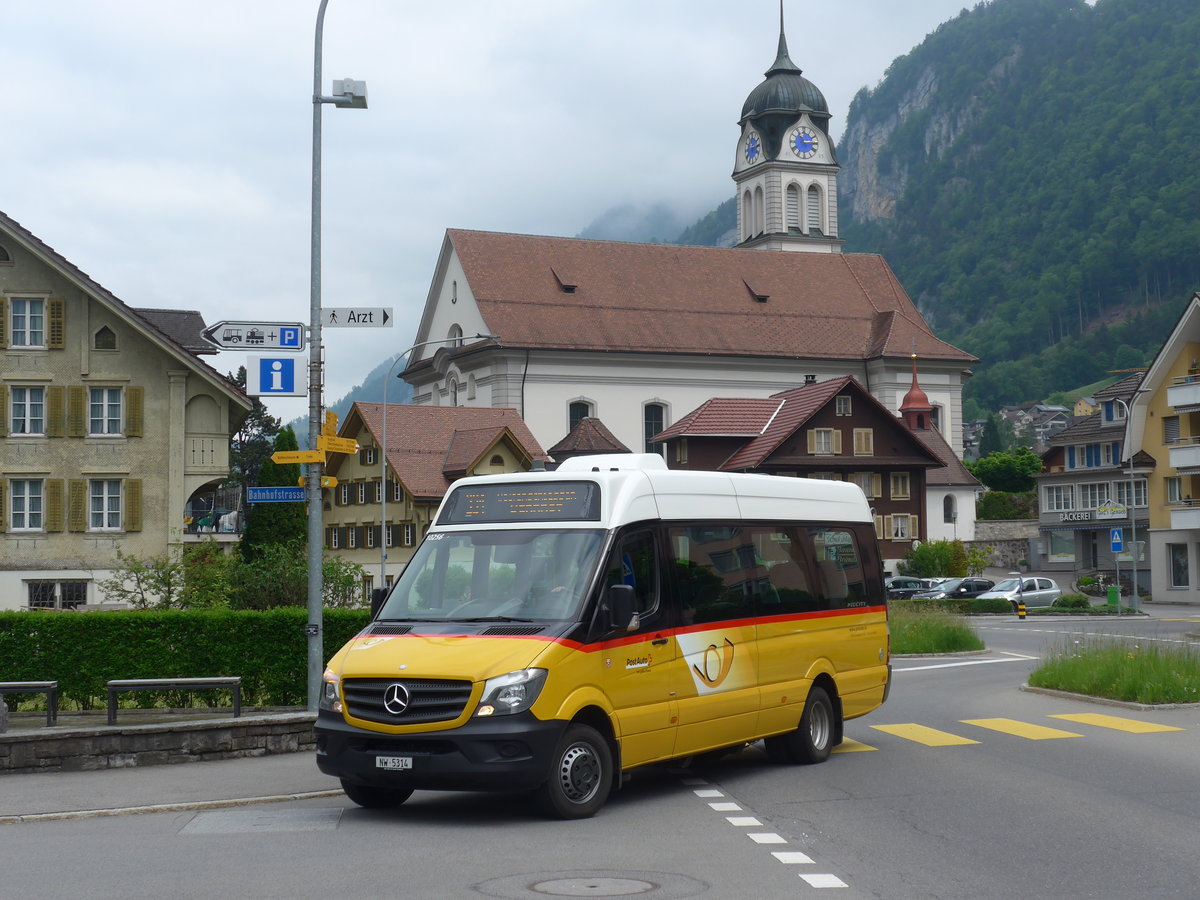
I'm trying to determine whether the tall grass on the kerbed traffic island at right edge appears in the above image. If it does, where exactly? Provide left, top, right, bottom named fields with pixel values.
left=1030, top=637, right=1200, bottom=704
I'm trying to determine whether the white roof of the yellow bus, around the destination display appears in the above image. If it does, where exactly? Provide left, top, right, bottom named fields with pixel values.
left=433, top=454, right=874, bottom=528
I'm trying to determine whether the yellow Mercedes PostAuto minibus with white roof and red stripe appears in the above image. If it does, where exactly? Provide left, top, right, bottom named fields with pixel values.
left=316, top=454, right=890, bottom=818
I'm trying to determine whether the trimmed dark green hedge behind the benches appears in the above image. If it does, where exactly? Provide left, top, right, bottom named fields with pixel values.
left=0, top=607, right=371, bottom=709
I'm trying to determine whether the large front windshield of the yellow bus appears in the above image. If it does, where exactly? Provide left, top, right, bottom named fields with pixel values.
left=378, top=528, right=604, bottom=622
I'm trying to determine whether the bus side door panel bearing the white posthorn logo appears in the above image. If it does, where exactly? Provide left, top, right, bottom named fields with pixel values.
left=668, top=524, right=766, bottom=756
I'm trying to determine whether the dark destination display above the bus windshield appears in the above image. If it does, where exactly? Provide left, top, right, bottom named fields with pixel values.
left=438, top=481, right=600, bottom=524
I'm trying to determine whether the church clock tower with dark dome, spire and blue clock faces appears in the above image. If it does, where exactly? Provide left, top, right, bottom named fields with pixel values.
left=733, top=6, right=842, bottom=253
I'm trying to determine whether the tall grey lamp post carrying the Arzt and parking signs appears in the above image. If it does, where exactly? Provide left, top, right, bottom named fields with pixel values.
left=305, top=0, right=367, bottom=713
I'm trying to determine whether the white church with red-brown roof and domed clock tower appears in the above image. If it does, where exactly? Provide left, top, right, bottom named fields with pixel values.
left=403, top=10, right=977, bottom=465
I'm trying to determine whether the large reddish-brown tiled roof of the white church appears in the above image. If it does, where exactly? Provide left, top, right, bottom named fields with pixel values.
left=427, top=229, right=977, bottom=370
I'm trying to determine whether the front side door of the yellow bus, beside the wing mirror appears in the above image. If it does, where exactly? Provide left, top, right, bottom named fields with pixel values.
left=596, top=529, right=676, bottom=767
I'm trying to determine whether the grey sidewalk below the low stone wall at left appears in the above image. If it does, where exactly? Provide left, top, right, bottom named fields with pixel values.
left=0, top=751, right=343, bottom=824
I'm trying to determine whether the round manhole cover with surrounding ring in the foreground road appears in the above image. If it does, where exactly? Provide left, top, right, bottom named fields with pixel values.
left=475, top=870, right=708, bottom=900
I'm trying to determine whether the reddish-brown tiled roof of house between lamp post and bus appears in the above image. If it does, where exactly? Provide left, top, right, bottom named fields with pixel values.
left=343, top=403, right=550, bottom=499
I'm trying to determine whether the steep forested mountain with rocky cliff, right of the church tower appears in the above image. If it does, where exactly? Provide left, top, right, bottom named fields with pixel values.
left=680, top=0, right=1200, bottom=414
